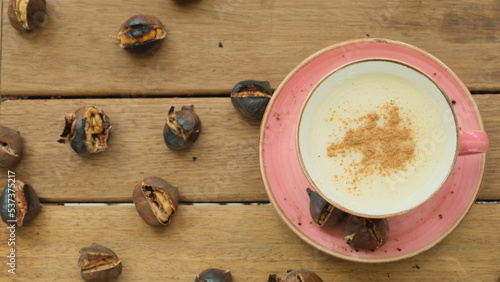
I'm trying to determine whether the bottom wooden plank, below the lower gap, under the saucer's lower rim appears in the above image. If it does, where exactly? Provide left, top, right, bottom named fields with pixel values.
left=0, top=204, right=500, bottom=281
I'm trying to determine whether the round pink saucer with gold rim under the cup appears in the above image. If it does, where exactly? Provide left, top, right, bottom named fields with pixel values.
left=260, top=39, right=485, bottom=263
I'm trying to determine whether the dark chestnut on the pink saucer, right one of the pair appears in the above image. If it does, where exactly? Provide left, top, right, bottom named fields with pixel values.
left=345, top=215, right=389, bottom=250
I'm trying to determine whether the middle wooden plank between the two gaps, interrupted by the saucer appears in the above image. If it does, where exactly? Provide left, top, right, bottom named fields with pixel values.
left=0, top=94, right=500, bottom=202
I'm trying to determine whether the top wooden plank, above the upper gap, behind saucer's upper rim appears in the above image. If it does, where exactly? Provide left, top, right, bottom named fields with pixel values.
left=0, top=0, right=500, bottom=96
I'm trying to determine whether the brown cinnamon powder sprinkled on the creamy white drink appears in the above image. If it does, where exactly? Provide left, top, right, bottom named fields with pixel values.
left=327, top=101, right=416, bottom=187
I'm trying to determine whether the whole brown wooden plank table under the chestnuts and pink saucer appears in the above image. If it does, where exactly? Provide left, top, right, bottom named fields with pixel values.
left=0, top=0, right=500, bottom=281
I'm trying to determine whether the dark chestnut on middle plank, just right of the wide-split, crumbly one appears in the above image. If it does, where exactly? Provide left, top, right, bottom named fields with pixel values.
left=163, top=105, right=201, bottom=151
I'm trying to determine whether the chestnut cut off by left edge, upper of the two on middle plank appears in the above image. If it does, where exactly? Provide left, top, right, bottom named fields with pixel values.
left=0, top=125, right=23, bottom=168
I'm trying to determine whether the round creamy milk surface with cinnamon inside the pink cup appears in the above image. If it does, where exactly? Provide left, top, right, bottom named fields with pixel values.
left=299, top=61, right=457, bottom=216
